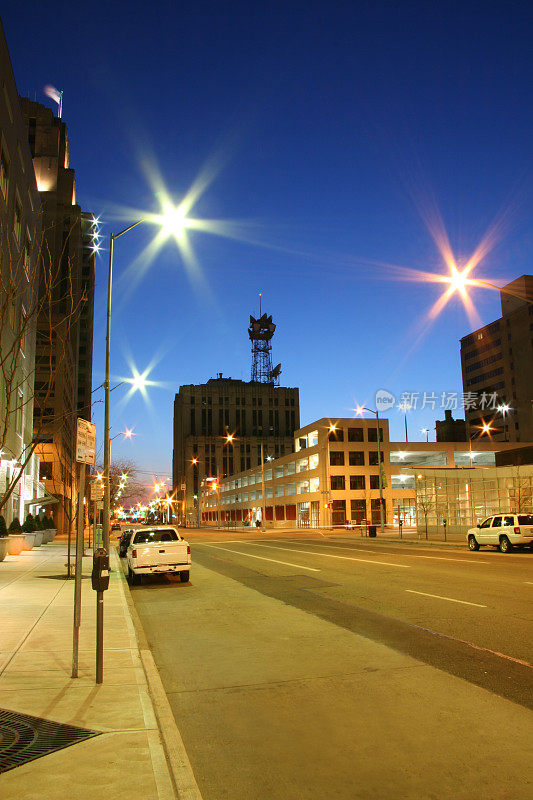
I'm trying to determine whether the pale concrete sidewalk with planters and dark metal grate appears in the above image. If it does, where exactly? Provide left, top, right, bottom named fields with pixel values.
left=0, top=542, right=199, bottom=800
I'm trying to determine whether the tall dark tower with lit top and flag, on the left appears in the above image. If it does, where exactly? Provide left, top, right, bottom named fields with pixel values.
left=21, top=98, right=94, bottom=532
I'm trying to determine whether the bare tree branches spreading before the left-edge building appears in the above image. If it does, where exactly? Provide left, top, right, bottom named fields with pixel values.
left=0, top=223, right=86, bottom=512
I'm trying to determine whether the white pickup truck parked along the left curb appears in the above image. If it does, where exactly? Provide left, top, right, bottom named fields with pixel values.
left=126, top=525, right=191, bottom=583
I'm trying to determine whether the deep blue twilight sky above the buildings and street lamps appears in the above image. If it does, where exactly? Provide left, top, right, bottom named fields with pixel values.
left=2, top=0, right=533, bottom=482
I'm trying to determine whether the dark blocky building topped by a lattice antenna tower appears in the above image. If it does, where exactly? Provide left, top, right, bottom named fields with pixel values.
left=172, top=307, right=300, bottom=524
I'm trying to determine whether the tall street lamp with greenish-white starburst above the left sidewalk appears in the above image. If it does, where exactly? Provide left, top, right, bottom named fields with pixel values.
left=102, top=205, right=187, bottom=552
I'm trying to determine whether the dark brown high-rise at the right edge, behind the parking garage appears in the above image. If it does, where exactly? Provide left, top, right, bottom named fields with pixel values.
left=461, top=275, right=533, bottom=442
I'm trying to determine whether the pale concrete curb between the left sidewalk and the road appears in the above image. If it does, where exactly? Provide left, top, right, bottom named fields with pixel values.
left=112, top=549, right=202, bottom=800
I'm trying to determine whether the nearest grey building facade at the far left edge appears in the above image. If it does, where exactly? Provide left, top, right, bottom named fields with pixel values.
left=0, top=23, right=43, bottom=525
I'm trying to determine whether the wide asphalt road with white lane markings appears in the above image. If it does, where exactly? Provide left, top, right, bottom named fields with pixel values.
left=132, top=531, right=533, bottom=800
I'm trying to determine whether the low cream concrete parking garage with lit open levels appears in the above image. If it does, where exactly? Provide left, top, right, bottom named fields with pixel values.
left=200, top=418, right=527, bottom=528
